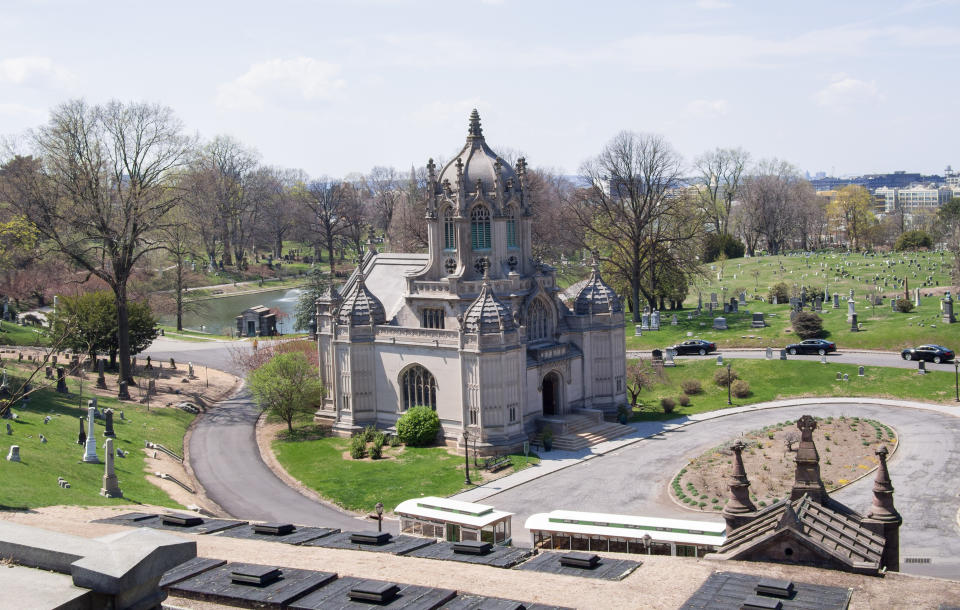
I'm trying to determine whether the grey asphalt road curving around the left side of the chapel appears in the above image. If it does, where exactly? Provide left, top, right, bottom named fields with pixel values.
left=145, top=339, right=384, bottom=531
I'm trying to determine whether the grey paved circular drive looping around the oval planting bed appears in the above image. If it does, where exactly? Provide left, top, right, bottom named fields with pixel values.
left=483, top=403, right=960, bottom=578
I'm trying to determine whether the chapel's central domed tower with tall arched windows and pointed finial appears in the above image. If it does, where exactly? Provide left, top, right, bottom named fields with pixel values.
left=420, top=109, right=531, bottom=280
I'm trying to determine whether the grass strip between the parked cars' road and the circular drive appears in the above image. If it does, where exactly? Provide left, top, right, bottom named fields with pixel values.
left=633, top=359, right=960, bottom=421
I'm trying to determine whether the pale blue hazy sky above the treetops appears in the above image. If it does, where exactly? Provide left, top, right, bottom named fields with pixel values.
left=0, top=0, right=960, bottom=176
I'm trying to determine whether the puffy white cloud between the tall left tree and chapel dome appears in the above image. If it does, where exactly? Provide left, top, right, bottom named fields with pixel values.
left=217, top=57, right=345, bottom=110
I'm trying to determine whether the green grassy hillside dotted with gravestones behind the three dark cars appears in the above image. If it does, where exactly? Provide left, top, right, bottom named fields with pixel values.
left=626, top=249, right=960, bottom=351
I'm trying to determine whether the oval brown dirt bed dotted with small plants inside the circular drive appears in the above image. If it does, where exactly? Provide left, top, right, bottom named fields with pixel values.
left=670, top=416, right=897, bottom=512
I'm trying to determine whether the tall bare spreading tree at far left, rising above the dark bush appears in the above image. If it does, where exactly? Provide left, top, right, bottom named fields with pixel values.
left=2, top=100, right=193, bottom=398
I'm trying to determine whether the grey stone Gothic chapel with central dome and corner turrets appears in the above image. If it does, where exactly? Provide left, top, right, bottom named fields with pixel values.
left=317, top=110, right=627, bottom=453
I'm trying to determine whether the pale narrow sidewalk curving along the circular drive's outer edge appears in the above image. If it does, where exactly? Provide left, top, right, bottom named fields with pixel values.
left=451, top=397, right=960, bottom=502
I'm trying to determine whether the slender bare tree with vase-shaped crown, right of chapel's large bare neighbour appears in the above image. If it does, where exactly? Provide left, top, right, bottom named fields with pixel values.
left=693, top=148, right=750, bottom=236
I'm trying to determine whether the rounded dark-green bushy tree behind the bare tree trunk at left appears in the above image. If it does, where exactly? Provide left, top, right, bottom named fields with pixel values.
left=49, top=290, right=159, bottom=365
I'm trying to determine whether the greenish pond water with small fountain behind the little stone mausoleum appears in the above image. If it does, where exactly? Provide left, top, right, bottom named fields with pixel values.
left=159, top=288, right=306, bottom=336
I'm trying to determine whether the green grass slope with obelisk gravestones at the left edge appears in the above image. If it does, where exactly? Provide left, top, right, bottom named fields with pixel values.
left=0, top=363, right=194, bottom=509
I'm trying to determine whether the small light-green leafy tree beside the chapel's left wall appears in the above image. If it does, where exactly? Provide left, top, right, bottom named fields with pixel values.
left=247, top=353, right=324, bottom=432
